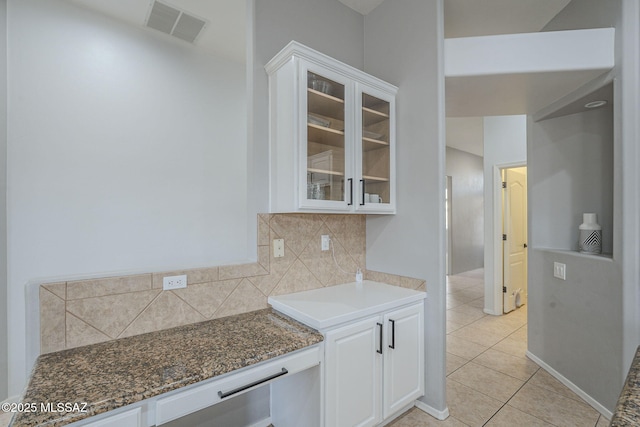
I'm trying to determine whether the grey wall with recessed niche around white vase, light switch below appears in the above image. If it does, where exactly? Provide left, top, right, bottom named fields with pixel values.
left=527, top=100, right=623, bottom=412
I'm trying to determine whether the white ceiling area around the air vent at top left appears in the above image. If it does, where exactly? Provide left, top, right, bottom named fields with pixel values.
left=68, top=0, right=247, bottom=62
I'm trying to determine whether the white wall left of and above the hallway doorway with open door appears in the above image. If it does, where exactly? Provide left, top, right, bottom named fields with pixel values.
left=484, top=115, right=527, bottom=315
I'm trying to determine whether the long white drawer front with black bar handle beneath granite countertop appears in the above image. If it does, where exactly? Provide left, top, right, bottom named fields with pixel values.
left=156, top=344, right=321, bottom=425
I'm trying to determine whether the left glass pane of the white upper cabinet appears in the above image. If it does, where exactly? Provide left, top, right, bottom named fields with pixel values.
left=307, top=72, right=345, bottom=201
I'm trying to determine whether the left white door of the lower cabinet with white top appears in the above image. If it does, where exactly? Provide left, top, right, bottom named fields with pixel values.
left=325, top=316, right=383, bottom=427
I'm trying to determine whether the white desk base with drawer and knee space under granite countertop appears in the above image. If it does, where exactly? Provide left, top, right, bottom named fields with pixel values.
left=71, top=344, right=323, bottom=427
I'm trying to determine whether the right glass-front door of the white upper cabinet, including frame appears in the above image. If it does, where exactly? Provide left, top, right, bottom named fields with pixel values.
left=356, top=84, right=396, bottom=213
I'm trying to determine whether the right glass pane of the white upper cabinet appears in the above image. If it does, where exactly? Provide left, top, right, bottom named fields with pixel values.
left=362, top=93, right=391, bottom=203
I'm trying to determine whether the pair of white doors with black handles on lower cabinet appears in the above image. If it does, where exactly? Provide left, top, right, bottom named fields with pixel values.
left=325, top=302, right=424, bottom=427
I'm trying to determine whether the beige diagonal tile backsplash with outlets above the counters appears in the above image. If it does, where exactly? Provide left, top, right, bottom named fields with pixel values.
left=40, top=214, right=425, bottom=354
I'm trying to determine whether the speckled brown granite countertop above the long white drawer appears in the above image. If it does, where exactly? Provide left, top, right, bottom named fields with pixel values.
left=10, top=309, right=322, bottom=427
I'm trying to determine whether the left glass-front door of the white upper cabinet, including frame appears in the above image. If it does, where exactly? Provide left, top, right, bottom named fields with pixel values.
left=298, top=61, right=353, bottom=211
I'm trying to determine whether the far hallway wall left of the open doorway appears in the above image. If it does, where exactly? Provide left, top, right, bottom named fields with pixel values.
left=446, top=147, right=484, bottom=274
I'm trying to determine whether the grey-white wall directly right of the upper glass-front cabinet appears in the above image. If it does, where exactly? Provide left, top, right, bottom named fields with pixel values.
left=365, top=0, right=448, bottom=418
